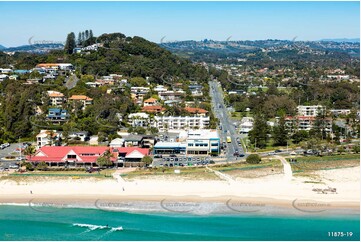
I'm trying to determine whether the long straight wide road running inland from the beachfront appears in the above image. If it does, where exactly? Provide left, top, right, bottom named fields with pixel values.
left=209, top=80, right=245, bottom=160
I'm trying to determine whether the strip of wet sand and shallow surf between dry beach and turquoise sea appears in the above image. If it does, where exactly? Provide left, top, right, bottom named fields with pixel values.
left=0, top=195, right=360, bottom=216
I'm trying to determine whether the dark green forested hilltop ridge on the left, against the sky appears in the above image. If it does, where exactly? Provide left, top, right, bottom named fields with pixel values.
left=0, top=33, right=208, bottom=81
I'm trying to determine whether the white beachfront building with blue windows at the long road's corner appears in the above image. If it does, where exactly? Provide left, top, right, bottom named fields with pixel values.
left=187, top=130, right=221, bottom=155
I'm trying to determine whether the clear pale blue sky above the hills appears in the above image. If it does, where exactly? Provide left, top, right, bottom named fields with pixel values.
left=0, top=2, right=360, bottom=47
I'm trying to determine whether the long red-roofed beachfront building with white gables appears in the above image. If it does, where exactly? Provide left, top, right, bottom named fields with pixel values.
left=26, top=146, right=149, bottom=167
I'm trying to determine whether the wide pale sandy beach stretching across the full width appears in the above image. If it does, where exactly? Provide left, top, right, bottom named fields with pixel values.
left=0, top=167, right=360, bottom=213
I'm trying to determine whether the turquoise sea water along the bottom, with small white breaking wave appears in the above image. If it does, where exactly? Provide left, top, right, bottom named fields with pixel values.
left=0, top=205, right=360, bottom=241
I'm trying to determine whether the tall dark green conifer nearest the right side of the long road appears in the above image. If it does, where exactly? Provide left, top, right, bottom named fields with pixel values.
left=248, top=113, right=268, bottom=148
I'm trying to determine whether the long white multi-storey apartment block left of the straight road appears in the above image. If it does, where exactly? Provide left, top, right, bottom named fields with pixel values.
left=153, top=116, right=210, bottom=132
